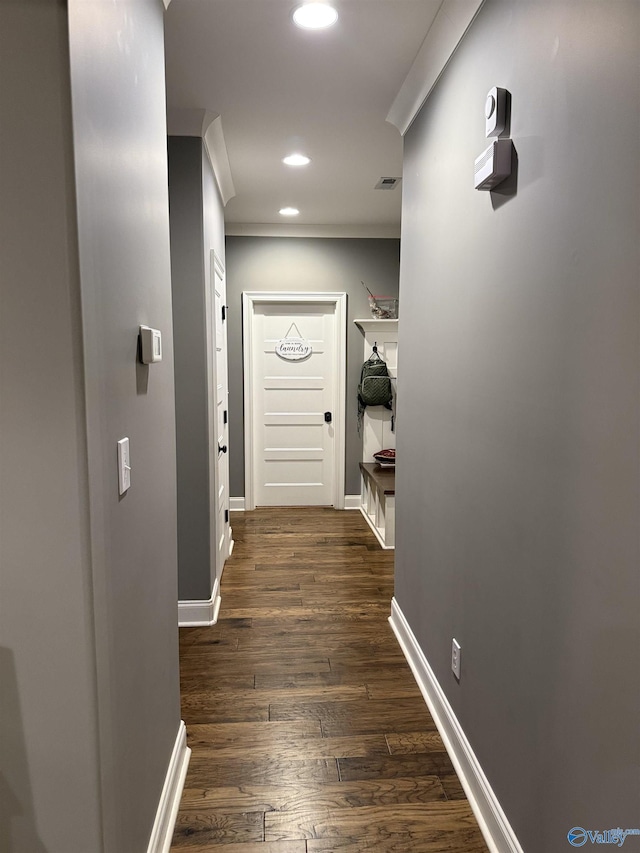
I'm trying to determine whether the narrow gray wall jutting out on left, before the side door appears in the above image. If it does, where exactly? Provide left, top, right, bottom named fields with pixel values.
left=168, top=136, right=224, bottom=601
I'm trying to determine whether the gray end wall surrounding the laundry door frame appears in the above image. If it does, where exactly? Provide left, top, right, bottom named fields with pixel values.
left=222, top=237, right=402, bottom=497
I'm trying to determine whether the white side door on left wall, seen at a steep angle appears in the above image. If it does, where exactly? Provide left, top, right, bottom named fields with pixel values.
left=209, top=251, right=233, bottom=580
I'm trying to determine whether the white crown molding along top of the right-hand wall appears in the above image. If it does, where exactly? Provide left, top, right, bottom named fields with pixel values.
left=387, top=0, right=484, bottom=136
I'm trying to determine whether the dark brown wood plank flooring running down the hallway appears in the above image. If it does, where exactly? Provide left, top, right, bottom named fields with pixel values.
left=171, top=508, right=487, bottom=853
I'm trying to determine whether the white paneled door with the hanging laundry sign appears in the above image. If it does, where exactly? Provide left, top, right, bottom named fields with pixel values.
left=245, top=294, right=344, bottom=506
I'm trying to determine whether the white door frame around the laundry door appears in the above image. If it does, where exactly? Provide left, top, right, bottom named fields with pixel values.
left=242, top=291, right=347, bottom=510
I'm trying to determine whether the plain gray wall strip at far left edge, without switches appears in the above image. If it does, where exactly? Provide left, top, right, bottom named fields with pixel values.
left=0, top=0, right=102, bottom=853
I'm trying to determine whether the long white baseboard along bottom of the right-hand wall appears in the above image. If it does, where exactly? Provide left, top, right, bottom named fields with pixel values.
left=389, top=598, right=523, bottom=853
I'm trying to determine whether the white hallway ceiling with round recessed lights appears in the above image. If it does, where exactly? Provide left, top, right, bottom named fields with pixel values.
left=166, top=0, right=442, bottom=235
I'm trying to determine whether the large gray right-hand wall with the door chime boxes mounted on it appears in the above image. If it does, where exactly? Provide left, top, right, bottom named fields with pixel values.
left=396, top=0, right=640, bottom=853
